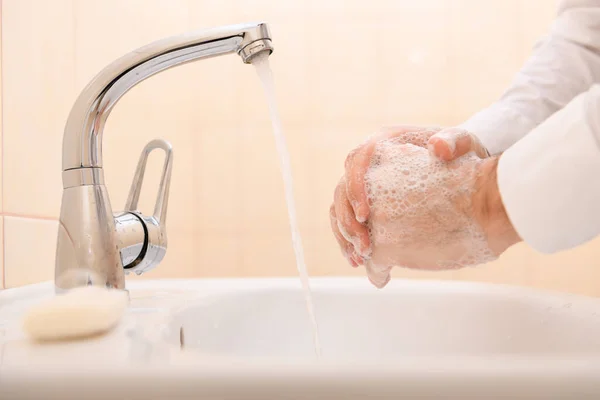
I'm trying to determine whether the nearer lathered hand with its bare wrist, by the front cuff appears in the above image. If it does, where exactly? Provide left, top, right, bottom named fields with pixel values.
left=365, top=138, right=518, bottom=287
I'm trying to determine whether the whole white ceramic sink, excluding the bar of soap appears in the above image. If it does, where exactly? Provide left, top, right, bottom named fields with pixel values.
left=0, top=278, right=600, bottom=400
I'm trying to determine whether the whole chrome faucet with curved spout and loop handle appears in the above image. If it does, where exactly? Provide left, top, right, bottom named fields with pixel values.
left=54, top=23, right=273, bottom=291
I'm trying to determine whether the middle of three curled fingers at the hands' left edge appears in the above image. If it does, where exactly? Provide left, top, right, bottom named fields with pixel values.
left=334, top=180, right=371, bottom=257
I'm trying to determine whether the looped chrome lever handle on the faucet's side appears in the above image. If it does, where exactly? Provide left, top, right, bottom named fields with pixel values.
left=125, top=139, right=173, bottom=226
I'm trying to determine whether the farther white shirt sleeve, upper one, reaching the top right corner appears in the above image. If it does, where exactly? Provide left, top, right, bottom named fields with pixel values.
left=460, top=0, right=600, bottom=154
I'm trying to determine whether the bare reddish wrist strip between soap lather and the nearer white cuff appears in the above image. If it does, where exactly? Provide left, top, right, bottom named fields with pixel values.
left=473, top=157, right=521, bottom=255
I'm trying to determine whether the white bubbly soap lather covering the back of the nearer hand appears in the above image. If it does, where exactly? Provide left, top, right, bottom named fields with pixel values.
left=365, top=136, right=496, bottom=269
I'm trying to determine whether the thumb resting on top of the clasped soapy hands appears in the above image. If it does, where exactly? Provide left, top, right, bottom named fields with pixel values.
left=427, top=128, right=489, bottom=161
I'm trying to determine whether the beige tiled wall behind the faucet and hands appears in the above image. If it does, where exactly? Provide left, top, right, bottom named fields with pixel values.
left=0, top=0, right=600, bottom=295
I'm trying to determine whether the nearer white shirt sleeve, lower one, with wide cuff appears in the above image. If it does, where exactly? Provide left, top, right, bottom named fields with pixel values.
left=498, top=85, right=600, bottom=253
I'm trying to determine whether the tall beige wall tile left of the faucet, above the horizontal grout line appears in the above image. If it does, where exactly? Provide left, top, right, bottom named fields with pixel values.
left=2, top=0, right=75, bottom=217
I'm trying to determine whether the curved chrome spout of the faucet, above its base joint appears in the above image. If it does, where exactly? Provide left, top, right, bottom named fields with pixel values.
left=63, top=23, right=273, bottom=171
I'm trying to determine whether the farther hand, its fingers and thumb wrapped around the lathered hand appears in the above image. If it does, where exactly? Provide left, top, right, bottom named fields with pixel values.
left=330, top=126, right=488, bottom=267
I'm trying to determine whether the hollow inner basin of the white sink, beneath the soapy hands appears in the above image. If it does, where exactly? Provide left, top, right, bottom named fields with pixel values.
left=166, top=280, right=600, bottom=362
